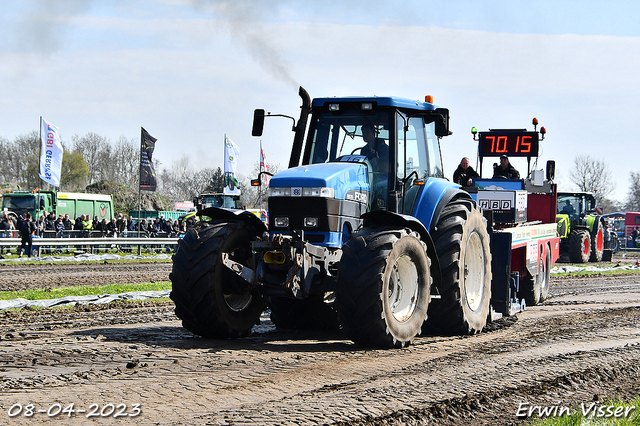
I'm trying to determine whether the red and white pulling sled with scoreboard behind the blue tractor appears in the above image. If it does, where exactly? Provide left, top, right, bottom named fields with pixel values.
left=468, top=118, right=560, bottom=313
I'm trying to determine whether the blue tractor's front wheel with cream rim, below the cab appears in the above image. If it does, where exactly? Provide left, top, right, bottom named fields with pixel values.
left=336, top=227, right=431, bottom=348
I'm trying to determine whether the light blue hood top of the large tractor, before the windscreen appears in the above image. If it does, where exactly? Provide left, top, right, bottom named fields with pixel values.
left=269, top=162, right=370, bottom=200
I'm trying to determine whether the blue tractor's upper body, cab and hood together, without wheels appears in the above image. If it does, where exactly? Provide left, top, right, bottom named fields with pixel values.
left=252, top=92, right=454, bottom=247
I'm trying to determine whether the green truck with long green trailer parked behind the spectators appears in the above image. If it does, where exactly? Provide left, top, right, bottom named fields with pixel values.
left=2, top=190, right=113, bottom=221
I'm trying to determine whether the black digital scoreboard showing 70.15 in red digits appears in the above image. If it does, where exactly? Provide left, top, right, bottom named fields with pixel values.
left=479, top=130, right=539, bottom=157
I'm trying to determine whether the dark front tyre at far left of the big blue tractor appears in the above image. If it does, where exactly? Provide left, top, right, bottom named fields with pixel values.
left=169, top=221, right=264, bottom=338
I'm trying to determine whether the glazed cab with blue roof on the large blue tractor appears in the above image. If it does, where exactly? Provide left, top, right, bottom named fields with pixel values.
left=302, top=98, right=449, bottom=212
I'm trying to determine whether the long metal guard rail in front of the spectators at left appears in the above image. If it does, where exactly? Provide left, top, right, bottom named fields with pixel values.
left=0, top=231, right=181, bottom=256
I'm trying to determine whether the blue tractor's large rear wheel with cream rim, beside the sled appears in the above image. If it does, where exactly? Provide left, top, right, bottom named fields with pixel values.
left=428, top=200, right=491, bottom=335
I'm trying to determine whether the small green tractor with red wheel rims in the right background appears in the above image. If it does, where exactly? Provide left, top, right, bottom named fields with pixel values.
left=556, top=192, right=605, bottom=263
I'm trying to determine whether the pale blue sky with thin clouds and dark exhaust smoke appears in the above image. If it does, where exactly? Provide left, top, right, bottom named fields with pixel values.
left=0, top=0, right=640, bottom=200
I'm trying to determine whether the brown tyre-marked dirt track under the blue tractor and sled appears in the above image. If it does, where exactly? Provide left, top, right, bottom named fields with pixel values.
left=0, top=257, right=640, bottom=425
